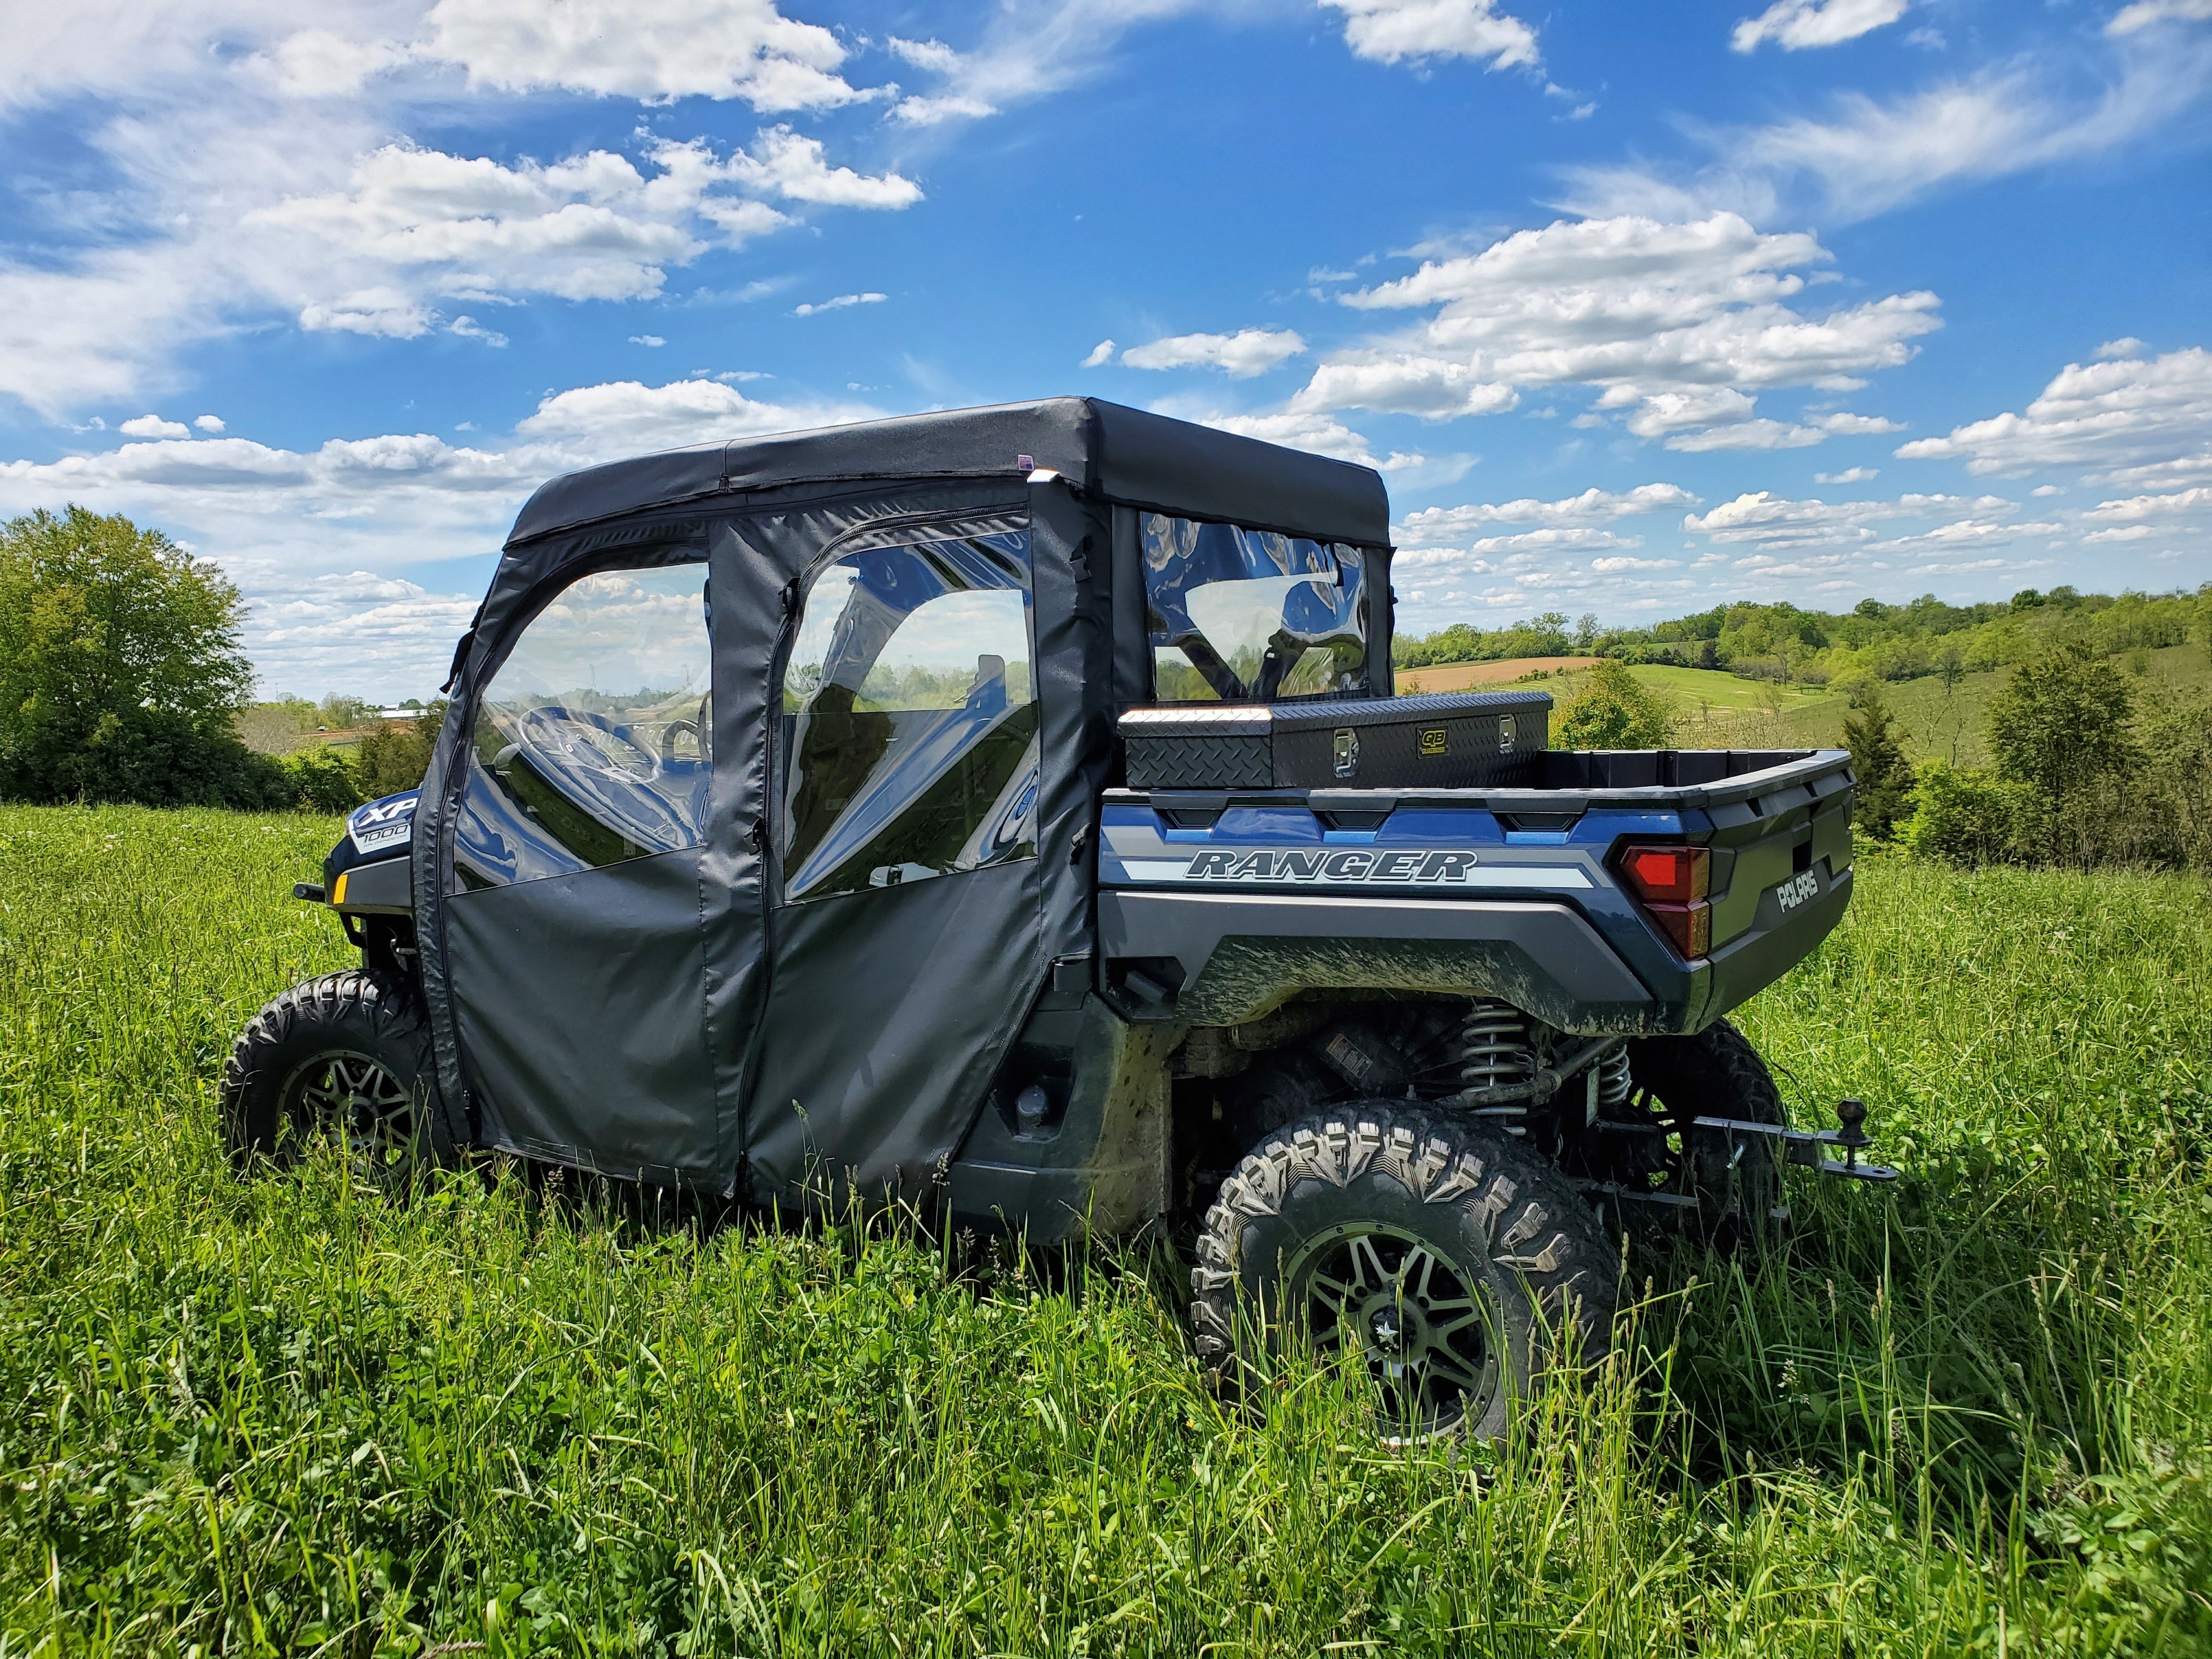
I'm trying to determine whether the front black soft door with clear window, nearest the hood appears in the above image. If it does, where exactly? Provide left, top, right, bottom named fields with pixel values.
left=444, top=560, right=735, bottom=1179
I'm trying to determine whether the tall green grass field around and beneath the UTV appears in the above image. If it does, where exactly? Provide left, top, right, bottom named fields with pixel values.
left=0, top=810, right=2212, bottom=1659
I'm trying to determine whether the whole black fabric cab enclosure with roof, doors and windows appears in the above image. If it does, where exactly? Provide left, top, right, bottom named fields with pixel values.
left=414, top=398, right=1389, bottom=1201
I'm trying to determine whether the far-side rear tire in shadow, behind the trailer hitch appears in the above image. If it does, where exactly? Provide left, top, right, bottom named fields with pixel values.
left=1623, top=1020, right=1790, bottom=1248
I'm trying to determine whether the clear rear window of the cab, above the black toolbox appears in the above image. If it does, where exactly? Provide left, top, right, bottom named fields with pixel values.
left=1139, top=513, right=1367, bottom=703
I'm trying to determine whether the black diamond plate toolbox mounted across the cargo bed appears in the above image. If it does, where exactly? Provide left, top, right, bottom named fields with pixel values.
left=1119, top=690, right=1550, bottom=789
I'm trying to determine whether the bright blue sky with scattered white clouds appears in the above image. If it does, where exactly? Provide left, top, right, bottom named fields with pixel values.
left=0, top=0, right=2212, bottom=697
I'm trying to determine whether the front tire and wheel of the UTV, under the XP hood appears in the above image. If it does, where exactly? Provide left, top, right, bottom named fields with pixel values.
left=219, top=969, right=454, bottom=1199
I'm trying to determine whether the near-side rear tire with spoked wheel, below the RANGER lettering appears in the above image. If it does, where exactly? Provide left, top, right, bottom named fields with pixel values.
left=1190, top=1099, right=1619, bottom=1440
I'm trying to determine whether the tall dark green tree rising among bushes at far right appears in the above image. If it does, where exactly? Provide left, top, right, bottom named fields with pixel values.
left=1989, top=641, right=2141, bottom=865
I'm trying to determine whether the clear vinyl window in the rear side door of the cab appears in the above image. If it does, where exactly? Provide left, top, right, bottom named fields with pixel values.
left=776, top=531, right=1037, bottom=900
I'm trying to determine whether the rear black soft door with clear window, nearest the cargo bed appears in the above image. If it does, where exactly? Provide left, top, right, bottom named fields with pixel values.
left=746, top=517, right=1042, bottom=1197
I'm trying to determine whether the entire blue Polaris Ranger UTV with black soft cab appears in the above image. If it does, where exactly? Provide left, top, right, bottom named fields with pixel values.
left=221, top=398, right=1887, bottom=1434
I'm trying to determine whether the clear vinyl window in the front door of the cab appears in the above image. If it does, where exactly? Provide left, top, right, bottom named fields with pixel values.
left=454, top=564, right=712, bottom=887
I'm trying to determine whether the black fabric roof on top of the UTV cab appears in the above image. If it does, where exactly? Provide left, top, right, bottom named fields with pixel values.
left=506, top=398, right=1389, bottom=546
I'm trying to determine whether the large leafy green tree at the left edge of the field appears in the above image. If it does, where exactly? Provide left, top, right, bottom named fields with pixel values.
left=0, top=506, right=287, bottom=808
